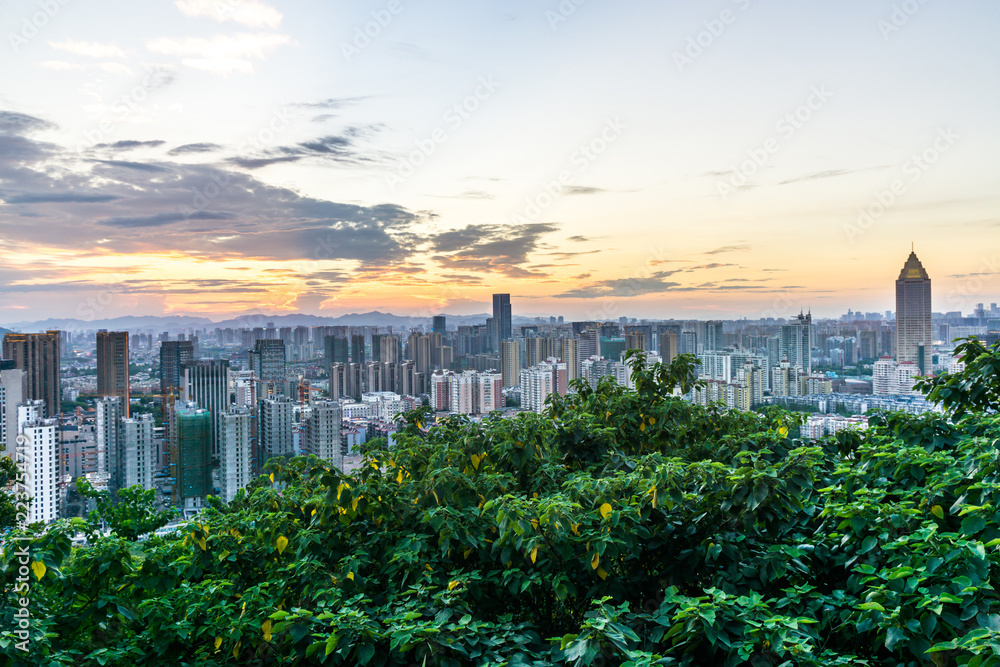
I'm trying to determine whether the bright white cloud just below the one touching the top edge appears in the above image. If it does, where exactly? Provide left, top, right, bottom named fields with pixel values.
left=146, top=33, right=293, bottom=75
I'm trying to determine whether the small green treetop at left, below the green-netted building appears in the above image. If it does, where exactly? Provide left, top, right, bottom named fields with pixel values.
left=76, top=477, right=174, bottom=542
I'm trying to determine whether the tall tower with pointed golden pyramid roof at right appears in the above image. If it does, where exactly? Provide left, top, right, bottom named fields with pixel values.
left=896, top=252, right=934, bottom=375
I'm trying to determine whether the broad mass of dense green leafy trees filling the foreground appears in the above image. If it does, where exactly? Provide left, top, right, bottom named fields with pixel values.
left=0, top=342, right=1000, bottom=667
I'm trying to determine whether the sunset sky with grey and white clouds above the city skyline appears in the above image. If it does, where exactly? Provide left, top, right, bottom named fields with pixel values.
left=0, top=0, right=1000, bottom=324
